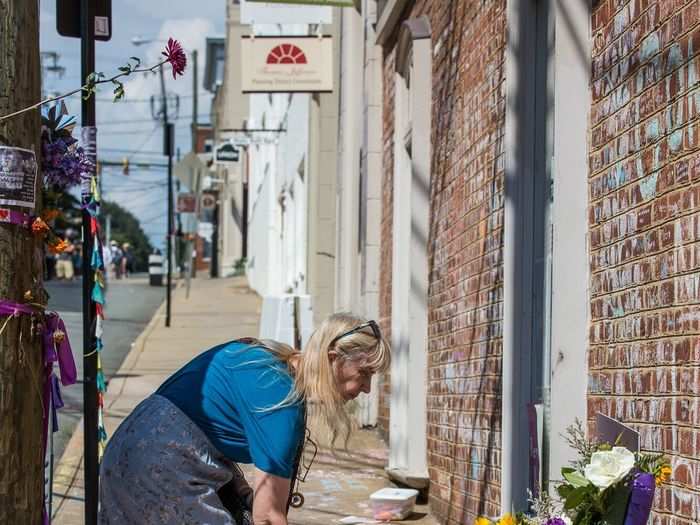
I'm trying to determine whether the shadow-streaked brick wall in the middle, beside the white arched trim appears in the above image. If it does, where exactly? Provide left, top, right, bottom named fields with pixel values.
left=380, top=0, right=505, bottom=524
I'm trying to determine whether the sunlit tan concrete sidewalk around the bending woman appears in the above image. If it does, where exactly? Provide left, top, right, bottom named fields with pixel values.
left=53, top=277, right=435, bottom=525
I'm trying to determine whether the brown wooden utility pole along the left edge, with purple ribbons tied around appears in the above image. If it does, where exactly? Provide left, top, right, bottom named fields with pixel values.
left=0, top=0, right=45, bottom=525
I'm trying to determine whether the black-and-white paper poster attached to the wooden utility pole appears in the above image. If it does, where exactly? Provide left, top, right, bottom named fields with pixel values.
left=0, top=146, right=37, bottom=208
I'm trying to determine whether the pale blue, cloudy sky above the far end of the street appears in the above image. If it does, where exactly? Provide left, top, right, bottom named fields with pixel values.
left=40, top=0, right=227, bottom=248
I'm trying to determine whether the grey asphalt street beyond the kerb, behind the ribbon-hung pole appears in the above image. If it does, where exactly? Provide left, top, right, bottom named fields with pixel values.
left=45, top=274, right=165, bottom=462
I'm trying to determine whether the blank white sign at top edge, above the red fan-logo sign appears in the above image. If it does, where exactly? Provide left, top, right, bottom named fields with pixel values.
left=241, top=0, right=333, bottom=25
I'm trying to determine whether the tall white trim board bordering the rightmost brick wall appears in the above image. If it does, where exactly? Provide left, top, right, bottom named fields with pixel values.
left=549, top=2, right=591, bottom=488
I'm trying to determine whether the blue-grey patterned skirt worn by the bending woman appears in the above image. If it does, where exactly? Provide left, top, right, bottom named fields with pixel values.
left=99, top=395, right=252, bottom=525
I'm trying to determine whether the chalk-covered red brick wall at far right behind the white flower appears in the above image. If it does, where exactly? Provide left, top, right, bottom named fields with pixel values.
left=588, top=0, right=700, bottom=524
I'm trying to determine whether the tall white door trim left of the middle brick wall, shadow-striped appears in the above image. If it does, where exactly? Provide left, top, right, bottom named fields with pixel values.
left=387, top=30, right=432, bottom=488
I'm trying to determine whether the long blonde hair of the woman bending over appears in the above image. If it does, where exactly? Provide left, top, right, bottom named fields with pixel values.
left=240, top=312, right=391, bottom=445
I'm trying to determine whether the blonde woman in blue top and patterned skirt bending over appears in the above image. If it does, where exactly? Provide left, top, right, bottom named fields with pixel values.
left=99, top=313, right=391, bottom=525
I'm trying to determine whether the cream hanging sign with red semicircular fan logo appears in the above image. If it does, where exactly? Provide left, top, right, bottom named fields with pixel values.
left=241, top=36, right=333, bottom=93
